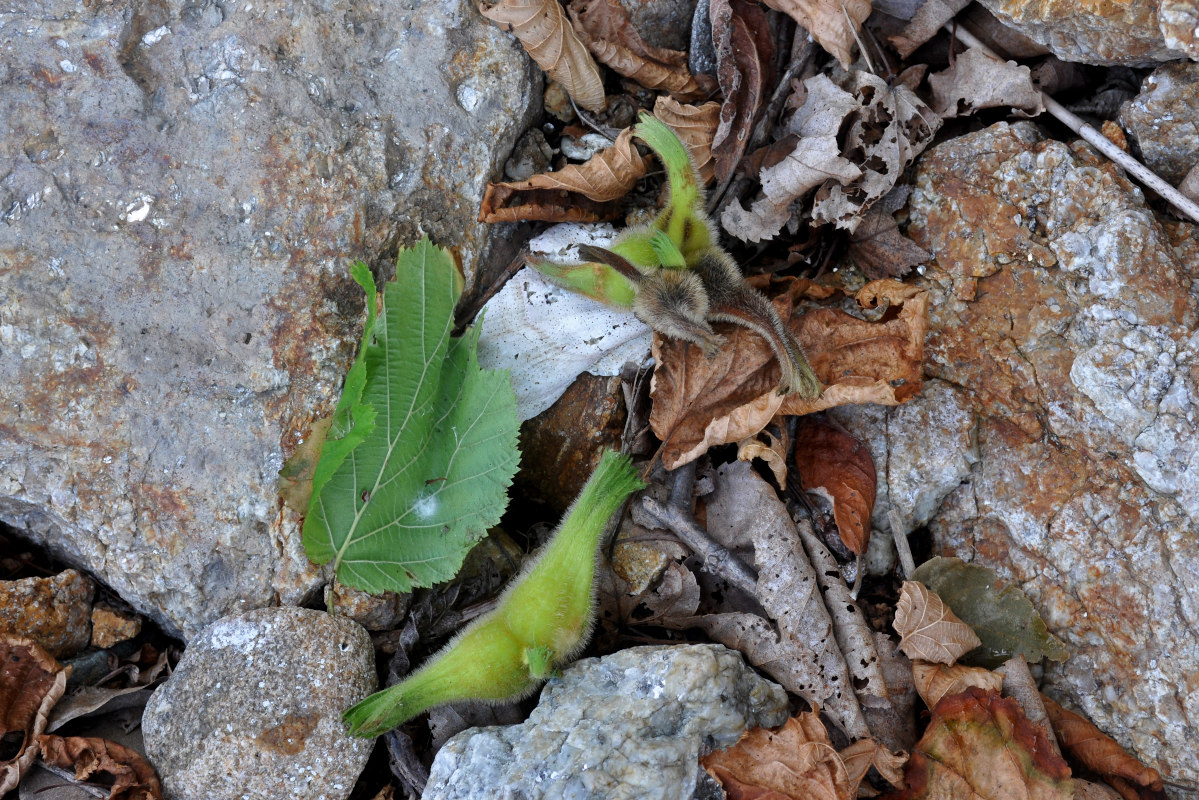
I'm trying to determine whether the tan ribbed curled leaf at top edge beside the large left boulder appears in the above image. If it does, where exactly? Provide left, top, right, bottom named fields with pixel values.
left=478, top=0, right=605, bottom=112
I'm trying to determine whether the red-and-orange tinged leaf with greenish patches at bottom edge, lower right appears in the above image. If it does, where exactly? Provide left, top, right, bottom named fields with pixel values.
left=888, top=688, right=1074, bottom=800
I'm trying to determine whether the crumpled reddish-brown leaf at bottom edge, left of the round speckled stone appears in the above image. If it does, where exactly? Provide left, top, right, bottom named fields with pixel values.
left=37, top=735, right=162, bottom=800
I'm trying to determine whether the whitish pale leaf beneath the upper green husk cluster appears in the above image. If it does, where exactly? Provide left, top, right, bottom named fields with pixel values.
left=478, top=224, right=652, bottom=421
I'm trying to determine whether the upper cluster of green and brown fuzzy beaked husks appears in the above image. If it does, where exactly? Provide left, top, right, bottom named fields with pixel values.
left=535, top=112, right=821, bottom=398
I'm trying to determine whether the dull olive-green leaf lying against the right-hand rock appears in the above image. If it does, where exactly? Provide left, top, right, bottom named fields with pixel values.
left=911, top=558, right=1070, bottom=668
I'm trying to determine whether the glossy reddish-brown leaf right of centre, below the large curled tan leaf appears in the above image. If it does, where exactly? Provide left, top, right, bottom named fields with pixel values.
left=795, top=415, right=877, bottom=554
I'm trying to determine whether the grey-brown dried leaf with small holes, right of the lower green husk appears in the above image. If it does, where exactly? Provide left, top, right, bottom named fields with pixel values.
left=679, top=462, right=869, bottom=739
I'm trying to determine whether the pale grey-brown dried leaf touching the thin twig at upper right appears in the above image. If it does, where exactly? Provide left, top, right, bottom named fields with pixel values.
left=928, top=47, right=1046, bottom=119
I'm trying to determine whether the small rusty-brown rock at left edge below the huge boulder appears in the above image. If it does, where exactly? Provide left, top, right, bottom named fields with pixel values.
left=0, top=570, right=96, bottom=658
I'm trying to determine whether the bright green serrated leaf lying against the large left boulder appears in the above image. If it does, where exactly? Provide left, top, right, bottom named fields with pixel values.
left=303, top=237, right=519, bottom=593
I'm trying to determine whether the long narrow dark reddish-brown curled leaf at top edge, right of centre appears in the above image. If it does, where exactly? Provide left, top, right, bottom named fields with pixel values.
left=710, top=0, right=775, bottom=182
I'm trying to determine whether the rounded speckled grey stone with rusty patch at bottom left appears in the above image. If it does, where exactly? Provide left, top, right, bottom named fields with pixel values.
left=141, top=608, right=376, bottom=800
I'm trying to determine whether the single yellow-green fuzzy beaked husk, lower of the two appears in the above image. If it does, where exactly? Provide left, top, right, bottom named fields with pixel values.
left=344, top=451, right=644, bottom=736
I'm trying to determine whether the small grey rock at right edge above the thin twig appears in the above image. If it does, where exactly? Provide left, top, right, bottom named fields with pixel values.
left=1120, top=61, right=1199, bottom=186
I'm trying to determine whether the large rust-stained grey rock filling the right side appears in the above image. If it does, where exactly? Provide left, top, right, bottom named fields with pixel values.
left=910, top=124, right=1199, bottom=783
